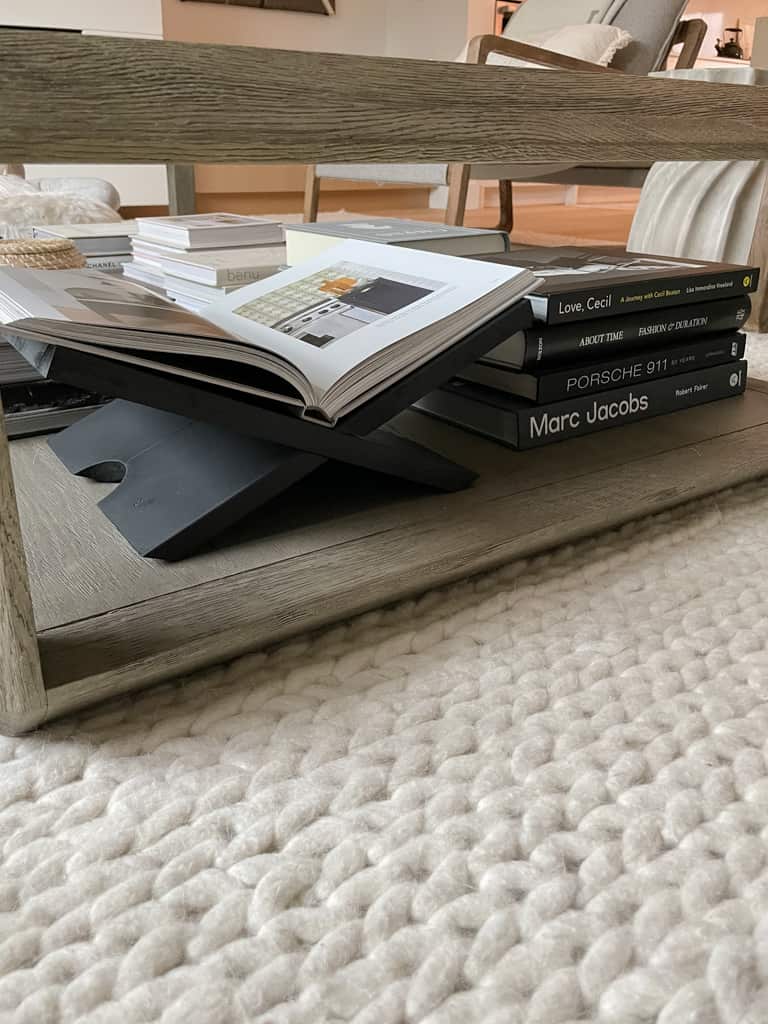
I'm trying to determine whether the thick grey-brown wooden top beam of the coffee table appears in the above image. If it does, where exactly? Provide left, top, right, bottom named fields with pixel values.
left=0, top=29, right=768, bottom=165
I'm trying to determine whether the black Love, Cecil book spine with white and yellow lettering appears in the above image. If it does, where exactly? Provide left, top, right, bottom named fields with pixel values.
left=546, top=267, right=758, bottom=324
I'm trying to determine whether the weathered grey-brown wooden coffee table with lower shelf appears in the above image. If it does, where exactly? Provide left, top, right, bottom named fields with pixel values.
left=0, top=24, right=768, bottom=732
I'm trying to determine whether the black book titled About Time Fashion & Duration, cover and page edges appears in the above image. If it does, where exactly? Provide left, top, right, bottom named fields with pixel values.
left=482, top=295, right=752, bottom=372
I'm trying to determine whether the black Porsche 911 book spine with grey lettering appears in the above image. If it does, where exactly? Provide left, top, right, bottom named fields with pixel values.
left=537, top=334, right=745, bottom=402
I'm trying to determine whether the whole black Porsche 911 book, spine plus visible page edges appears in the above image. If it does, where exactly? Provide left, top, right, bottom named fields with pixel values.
left=458, top=333, right=745, bottom=404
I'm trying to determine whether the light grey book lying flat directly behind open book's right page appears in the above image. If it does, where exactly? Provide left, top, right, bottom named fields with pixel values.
left=285, top=217, right=509, bottom=266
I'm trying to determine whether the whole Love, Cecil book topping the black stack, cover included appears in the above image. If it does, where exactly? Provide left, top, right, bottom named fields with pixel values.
left=473, top=246, right=759, bottom=324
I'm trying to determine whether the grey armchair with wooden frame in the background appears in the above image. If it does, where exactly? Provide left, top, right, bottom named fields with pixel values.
left=304, top=0, right=707, bottom=230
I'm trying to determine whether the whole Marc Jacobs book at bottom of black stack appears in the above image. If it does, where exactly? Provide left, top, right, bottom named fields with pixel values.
left=415, top=359, right=746, bottom=449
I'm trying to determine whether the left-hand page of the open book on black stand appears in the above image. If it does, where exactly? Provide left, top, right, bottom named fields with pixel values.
left=0, top=267, right=232, bottom=340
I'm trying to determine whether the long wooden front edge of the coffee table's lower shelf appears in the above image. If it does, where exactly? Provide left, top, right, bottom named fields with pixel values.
left=40, top=391, right=768, bottom=717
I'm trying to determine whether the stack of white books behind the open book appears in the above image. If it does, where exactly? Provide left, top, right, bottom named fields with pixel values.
left=123, top=213, right=286, bottom=312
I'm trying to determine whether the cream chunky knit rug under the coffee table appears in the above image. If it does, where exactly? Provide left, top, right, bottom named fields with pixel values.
left=0, top=339, right=768, bottom=1024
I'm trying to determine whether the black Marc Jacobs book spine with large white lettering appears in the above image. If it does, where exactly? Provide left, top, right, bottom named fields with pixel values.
left=514, top=360, right=746, bottom=449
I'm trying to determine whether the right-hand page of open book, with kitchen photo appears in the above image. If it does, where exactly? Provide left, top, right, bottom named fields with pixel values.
left=205, top=241, right=532, bottom=396
